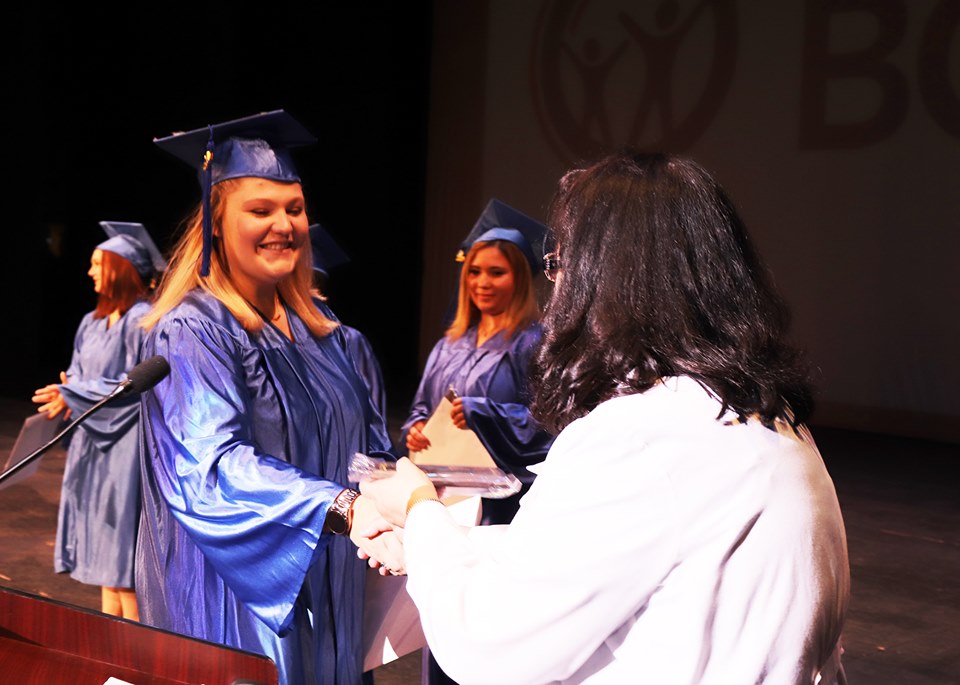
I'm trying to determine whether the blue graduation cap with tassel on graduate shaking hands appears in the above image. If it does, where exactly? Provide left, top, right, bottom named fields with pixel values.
left=153, top=109, right=317, bottom=276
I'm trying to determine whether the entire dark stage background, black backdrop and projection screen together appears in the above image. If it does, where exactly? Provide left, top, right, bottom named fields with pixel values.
left=0, top=0, right=960, bottom=444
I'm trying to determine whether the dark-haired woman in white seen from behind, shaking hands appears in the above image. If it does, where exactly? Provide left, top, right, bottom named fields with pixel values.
left=361, top=151, right=850, bottom=685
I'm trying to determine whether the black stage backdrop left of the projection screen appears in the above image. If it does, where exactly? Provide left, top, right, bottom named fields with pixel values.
left=0, top=2, right=431, bottom=406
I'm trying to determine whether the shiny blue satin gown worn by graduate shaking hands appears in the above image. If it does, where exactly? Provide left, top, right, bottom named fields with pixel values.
left=137, top=290, right=390, bottom=685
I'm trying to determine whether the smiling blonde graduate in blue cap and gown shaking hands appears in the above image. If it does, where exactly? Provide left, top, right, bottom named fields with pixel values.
left=137, top=111, right=402, bottom=685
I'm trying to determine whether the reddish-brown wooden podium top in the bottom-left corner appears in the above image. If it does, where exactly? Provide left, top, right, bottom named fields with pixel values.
left=0, top=587, right=277, bottom=685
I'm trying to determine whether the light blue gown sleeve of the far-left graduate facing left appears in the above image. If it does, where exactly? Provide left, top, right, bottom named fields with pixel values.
left=60, top=309, right=143, bottom=452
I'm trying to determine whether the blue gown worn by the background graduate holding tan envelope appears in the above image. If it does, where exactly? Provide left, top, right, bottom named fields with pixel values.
left=401, top=323, right=553, bottom=524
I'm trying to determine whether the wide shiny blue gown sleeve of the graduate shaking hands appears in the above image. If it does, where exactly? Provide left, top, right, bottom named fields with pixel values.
left=144, top=319, right=344, bottom=634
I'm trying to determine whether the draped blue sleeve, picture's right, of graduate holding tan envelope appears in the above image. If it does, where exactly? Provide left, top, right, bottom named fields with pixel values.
left=463, top=327, right=553, bottom=483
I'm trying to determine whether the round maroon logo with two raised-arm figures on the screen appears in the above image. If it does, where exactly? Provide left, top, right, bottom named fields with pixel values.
left=530, top=0, right=737, bottom=163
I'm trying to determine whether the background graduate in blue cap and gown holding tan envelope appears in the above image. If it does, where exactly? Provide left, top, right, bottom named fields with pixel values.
left=401, top=199, right=553, bottom=685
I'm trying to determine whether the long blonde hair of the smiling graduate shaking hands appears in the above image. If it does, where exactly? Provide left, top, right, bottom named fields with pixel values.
left=141, top=179, right=338, bottom=336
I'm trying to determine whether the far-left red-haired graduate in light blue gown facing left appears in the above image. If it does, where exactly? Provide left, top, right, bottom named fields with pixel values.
left=33, top=221, right=166, bottom=621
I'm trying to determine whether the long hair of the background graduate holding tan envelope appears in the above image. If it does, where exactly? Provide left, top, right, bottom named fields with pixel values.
left=444, top=240, right=540, bottom=340
